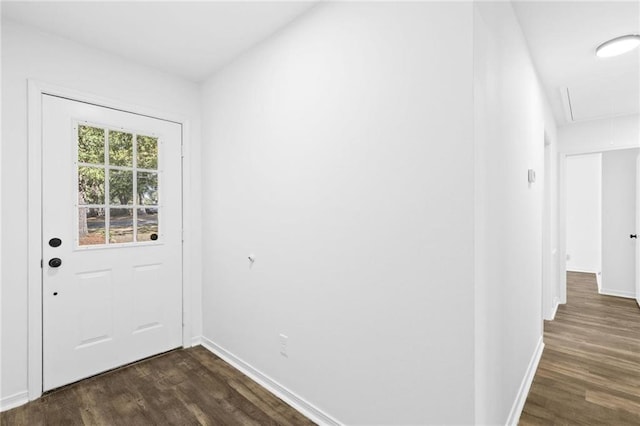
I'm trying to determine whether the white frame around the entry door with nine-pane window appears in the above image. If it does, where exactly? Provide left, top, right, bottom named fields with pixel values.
left=27, top=79, right=198, bottom=401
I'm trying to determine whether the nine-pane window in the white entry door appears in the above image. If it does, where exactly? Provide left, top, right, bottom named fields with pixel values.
left=75, top=123, right=160, bottom=246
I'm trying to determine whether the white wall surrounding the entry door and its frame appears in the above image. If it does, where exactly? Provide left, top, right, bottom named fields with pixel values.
left=0, top=21, right=201, bottom=401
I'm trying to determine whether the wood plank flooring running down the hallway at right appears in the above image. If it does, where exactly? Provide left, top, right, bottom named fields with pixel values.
left=520, top=272, right=640, bottom=426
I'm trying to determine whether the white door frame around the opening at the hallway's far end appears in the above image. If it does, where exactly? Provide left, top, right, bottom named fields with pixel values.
left=558, top=145, right=640, bottom=304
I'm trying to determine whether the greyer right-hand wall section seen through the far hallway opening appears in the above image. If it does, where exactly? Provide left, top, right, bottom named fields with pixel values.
left=601, top=149, right=640, bottom=298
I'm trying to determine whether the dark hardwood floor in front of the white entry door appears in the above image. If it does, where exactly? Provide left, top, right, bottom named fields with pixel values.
left=0, top=346, right=314, bottom=426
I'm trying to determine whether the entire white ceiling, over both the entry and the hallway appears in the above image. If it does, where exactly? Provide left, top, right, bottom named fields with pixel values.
left=2, top=0, right=640, bottom=125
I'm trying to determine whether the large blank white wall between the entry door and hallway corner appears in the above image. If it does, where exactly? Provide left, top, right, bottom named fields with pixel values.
left=203, top=3, right=476, bottom=424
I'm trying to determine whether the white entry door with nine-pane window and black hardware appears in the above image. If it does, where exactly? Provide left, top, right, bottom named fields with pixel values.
left=42, top=95, right=182, bottom=391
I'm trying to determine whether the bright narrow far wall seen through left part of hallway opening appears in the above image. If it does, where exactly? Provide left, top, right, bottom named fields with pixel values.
left=566, top=154, right=602, bottom=273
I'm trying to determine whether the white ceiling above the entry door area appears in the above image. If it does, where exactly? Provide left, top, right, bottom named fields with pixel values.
left=2, top=0, right=316, bottom=82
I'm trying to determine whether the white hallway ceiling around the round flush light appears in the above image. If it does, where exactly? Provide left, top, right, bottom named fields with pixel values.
left=512, top=0, right=640, bottom=125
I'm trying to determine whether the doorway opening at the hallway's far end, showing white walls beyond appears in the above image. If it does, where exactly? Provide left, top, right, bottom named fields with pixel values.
left=561, top=148, right=640, bottom=302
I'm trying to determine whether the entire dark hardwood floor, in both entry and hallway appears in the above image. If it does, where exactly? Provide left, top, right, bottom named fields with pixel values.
left=0, top=273, right=640, bottom=426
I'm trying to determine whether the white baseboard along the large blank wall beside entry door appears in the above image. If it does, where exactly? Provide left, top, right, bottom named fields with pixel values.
left=202, top=337, right=342, bottom=425
